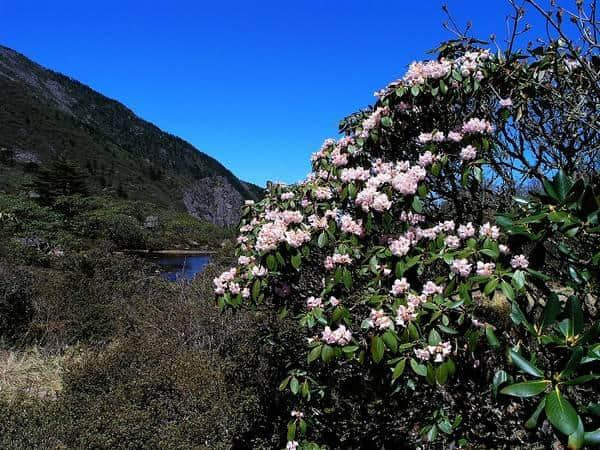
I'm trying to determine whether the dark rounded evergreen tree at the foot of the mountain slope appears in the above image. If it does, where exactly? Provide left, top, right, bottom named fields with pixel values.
left=32, top=155, right=88, bottom=203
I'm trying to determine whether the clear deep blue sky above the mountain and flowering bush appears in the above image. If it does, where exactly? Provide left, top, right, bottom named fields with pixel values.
left=0, top=0, right=539, bottom=185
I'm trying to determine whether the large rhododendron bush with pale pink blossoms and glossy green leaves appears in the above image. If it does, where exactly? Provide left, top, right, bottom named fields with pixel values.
left=214, top=11, right=600, bottom=449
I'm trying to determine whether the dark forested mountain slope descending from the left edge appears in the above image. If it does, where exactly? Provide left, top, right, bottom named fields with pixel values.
left=0, top=46, right=262, bottom=225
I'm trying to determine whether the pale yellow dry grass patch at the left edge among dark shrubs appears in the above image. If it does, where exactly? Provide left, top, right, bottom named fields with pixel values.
left=0, top=347, right=80, bottom=401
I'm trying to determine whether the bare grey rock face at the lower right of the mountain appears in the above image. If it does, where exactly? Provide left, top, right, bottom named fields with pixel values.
left=183, top=176, right=244, bottom=225
